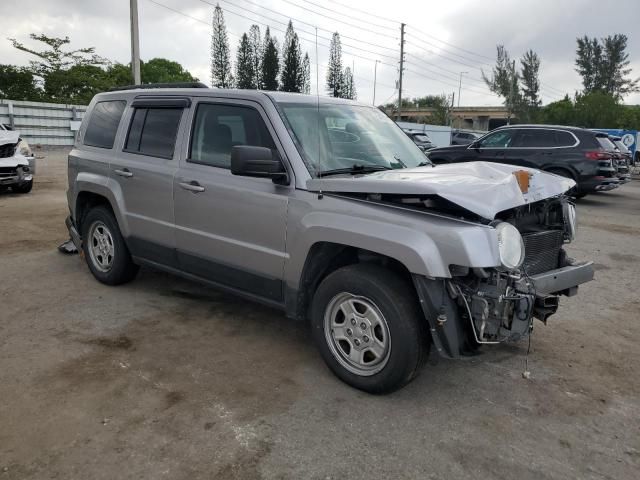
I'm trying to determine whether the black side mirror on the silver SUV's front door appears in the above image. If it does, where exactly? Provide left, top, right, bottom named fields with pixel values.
left=231, top=145, right=289, bottom=185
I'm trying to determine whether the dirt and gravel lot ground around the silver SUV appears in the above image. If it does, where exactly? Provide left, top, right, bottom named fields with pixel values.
left=0, top=150, right=640, bottom=480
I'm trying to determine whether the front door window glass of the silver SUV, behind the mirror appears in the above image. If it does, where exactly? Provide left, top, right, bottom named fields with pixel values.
left=188, top=103, right=276, bottom=168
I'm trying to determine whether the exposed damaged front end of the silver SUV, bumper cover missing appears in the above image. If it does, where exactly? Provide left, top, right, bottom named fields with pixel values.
left=414, top=196, right=593, bottom=358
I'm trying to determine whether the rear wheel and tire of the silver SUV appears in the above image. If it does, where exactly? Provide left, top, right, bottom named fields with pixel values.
left=82, top=206, right=139, bottom=285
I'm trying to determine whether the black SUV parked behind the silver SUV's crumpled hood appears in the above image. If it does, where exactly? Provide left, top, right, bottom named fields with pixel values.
left=428, top=125, right=619, bottom=197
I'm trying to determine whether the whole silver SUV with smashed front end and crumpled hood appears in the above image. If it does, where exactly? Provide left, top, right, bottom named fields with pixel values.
left=67, top=86, right=593, bottom=392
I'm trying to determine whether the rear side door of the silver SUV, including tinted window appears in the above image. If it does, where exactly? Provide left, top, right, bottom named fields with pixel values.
left=110, top=97, right=190, bottom=266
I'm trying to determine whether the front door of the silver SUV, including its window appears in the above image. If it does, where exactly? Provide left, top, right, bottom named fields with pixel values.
left=174, top=99, right=293, bottom=302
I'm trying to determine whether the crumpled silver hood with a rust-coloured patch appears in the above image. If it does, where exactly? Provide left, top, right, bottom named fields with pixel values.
left=307, top=162, right=576, bottom=220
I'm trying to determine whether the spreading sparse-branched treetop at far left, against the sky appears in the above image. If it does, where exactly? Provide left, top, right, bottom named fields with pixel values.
left=9, top=33, right=109, bottom=81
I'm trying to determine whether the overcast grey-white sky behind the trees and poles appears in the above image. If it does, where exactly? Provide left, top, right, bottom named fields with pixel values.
left=0, top=0, right=640, bottom=105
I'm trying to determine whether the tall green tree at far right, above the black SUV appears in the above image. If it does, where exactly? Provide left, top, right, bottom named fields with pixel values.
left=575, top=34, right=640, bottom=99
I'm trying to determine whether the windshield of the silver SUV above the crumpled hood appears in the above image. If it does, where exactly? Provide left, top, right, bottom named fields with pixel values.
left=278, top=103, right=430, bottom=176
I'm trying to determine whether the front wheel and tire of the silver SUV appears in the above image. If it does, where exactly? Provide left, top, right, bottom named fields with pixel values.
left=311, top=264, right=430, bottom=393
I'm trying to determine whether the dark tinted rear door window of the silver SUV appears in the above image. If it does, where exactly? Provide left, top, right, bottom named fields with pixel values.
left=124, top=108, right=183, bottom=159
